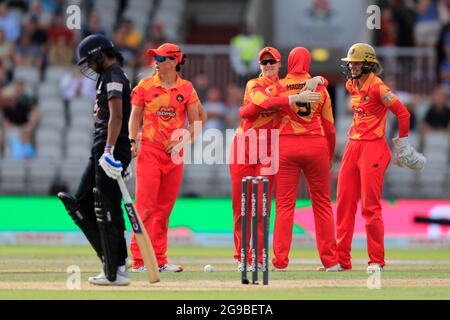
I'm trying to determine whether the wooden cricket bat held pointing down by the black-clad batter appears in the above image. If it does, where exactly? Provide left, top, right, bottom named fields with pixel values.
left=117, top=177, right=160, bottom=283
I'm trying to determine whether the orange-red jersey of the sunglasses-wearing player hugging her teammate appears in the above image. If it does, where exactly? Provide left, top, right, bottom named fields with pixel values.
left=236, top=77, right=280, bottom=134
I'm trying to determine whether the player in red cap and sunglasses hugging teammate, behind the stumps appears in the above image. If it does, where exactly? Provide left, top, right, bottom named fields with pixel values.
left=230, top=47, right=322, bottom=263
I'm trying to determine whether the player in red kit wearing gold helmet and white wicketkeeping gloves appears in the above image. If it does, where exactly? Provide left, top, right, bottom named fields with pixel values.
left=336, top=43, right=426, bottom=272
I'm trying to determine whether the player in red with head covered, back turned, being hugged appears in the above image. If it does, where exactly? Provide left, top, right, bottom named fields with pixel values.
left=272, top=47, right=339, bottom=271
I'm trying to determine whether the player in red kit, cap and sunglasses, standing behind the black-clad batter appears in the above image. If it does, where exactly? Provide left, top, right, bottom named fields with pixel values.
left=129, top=43, right=206, bottom=272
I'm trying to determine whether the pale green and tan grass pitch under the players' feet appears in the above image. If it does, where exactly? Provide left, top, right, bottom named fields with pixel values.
left=0, top=246, right=450, bottom=300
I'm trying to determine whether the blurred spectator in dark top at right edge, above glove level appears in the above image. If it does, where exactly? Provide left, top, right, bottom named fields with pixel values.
left=422, top=86, right=450, bottom=135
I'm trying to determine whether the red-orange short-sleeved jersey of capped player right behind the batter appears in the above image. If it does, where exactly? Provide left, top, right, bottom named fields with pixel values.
left=131, top=75, right=199, bottom=150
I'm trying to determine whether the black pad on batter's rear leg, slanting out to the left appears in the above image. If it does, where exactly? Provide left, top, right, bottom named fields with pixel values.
left=58, top=192, right=102, bottom=258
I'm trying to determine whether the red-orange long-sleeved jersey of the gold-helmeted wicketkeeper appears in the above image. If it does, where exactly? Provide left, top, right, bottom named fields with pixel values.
left=346, top=73, right=409, bottom=140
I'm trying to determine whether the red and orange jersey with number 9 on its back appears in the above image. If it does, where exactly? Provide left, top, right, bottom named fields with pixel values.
left=278, top=73, right=334, bottom=136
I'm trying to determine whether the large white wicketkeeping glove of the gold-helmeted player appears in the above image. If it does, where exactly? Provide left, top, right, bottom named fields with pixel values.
left=392, top=137, right=427, bottom=171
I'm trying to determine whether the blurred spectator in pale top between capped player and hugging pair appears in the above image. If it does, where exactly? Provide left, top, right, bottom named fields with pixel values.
left=203, top=88, right=227, bottom=130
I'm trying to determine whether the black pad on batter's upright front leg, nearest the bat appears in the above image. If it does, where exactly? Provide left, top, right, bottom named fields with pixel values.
left=93, top=188, right=124, bottom=281
